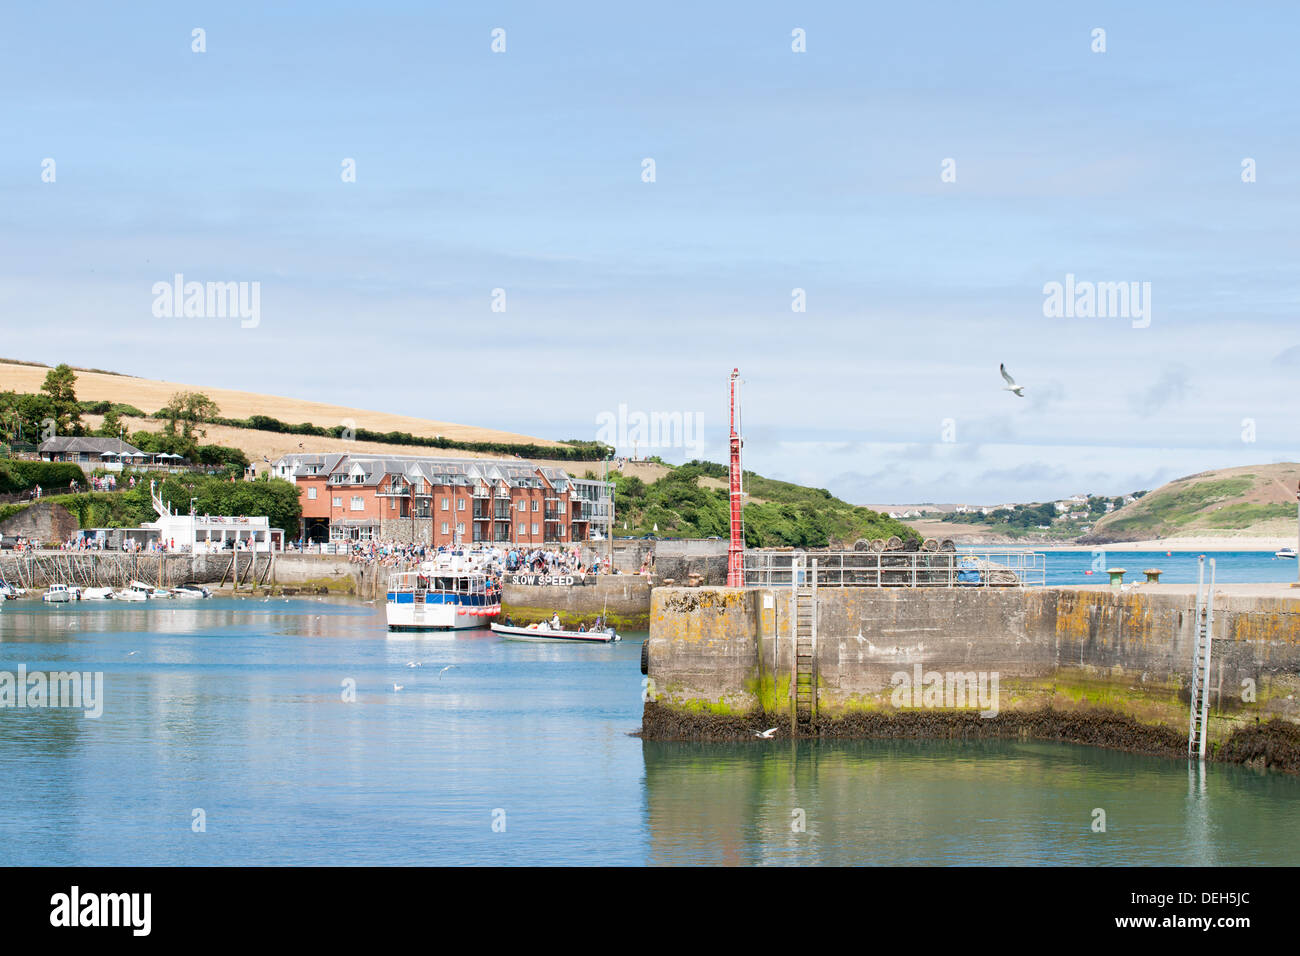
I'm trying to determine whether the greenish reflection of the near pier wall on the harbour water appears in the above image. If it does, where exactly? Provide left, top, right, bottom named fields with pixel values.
left=644, top=741, right=1300, bottom=865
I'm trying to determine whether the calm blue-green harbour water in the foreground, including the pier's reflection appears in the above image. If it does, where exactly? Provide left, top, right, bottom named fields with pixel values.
left=0, top=598, right=1300, bottom=865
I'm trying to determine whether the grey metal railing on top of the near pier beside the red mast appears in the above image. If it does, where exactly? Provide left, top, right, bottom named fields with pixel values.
left=745, top=549, right=1047, bottom=588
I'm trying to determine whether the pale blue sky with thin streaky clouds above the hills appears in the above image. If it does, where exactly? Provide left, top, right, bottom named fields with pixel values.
left=0, top=1, right=1300, bottom=503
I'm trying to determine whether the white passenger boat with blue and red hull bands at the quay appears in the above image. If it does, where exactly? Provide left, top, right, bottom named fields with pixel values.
left=385, top=549, right=501, bottom=631
